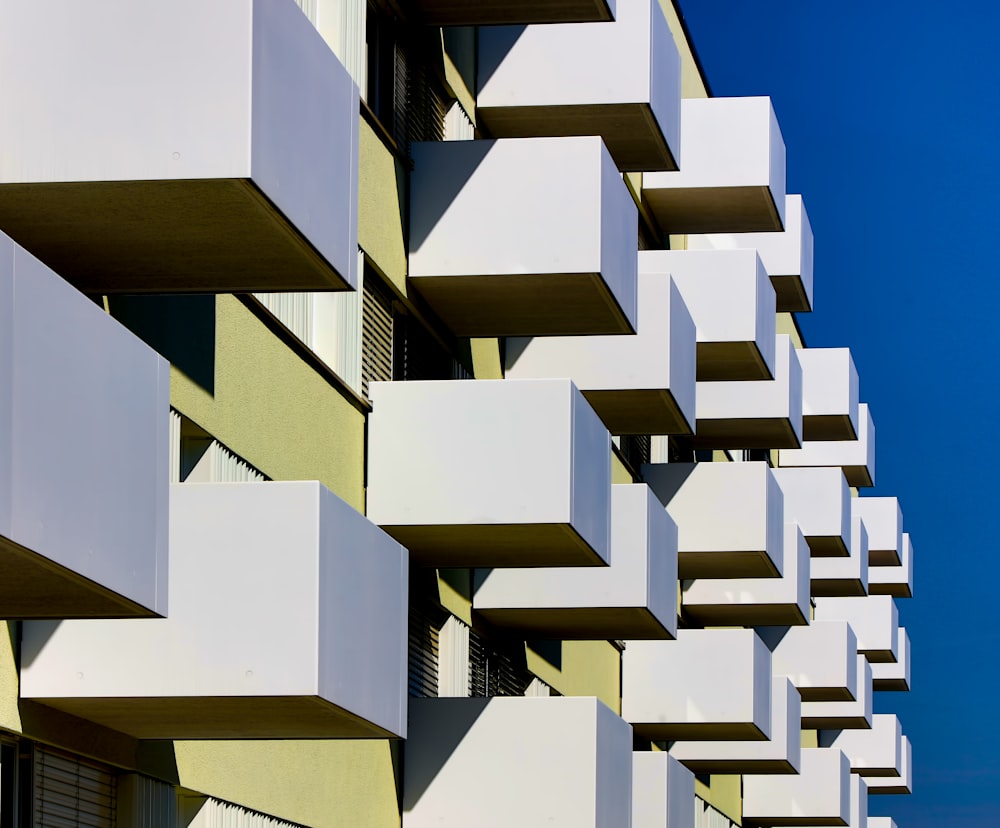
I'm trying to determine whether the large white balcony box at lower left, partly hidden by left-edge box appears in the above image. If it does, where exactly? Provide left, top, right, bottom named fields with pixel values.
left=21, top=482, right=408, bottom=739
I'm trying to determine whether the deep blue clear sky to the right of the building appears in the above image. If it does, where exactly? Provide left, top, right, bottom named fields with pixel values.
left=681, top=0, right=1000, bottom=828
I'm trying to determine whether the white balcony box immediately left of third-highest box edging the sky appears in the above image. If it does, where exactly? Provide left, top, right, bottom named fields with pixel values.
left=694, top=334, right=802, bottom=449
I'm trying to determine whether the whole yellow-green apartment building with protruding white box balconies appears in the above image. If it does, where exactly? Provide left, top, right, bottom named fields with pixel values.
left=0, top=0, right=913, bottom=828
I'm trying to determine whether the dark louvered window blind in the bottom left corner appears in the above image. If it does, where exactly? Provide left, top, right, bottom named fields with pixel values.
left=32, top=746, right=116, bottom=828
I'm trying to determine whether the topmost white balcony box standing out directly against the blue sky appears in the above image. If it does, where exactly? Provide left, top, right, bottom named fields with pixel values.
left=642, top=98, right=785, bottom=233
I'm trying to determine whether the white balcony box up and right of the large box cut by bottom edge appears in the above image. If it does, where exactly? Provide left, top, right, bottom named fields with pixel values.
left=622, top=630, right=771, bottom=741
